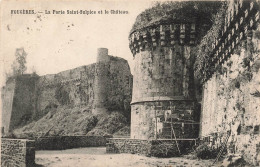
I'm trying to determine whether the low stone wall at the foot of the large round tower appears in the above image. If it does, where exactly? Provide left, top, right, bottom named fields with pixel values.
left=106, top=138, right=195, bottom=157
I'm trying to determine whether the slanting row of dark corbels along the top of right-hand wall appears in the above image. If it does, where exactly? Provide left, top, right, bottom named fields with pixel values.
left=195, top=1, right=259, bottom=83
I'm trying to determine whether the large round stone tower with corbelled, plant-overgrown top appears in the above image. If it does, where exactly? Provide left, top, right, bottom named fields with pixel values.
left=129, top=2, right=220, bottom=139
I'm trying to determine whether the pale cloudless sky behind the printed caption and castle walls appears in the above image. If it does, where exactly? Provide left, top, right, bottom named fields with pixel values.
left=0, top=0, right=154, bottom=84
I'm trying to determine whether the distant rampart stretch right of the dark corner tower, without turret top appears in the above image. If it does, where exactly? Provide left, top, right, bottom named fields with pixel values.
left=36, top=52, right=132, bottom=117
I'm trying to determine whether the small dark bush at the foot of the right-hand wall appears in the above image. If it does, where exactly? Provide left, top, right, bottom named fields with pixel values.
left=195, top=144, right=219, bottom=159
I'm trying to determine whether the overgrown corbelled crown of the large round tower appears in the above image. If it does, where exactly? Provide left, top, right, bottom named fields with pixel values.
left=129, top=2, right=222, bottom=56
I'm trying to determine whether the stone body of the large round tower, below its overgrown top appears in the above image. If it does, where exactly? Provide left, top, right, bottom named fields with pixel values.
left=129, top=23, right=198, bottom=139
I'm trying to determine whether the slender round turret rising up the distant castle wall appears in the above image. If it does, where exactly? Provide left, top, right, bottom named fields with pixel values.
left=92, top=48, right=110, bottom=114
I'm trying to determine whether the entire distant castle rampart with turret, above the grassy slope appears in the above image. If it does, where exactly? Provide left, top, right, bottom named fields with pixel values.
left=2, top=48, right=132, bottom=133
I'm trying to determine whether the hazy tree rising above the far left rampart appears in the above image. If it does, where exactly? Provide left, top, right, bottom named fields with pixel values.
left=12, top=48, right=27, bottom=75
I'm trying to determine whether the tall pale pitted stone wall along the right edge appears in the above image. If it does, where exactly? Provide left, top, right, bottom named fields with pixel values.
left=200, top=1, right=260, bottom=166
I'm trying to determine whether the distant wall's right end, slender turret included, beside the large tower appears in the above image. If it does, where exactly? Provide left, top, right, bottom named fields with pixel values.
left=93, top=48, right=132, bottom=114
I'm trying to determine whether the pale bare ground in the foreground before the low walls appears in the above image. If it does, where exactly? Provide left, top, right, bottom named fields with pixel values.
left=36, top=147, right=218, bottom=167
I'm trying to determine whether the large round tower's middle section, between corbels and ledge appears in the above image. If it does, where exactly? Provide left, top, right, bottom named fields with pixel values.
left=132, top=44, right=194, bottom=103
